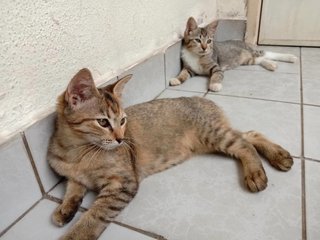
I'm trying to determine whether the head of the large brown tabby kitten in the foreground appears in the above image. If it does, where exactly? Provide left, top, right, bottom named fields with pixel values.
left=57, top=69, right=132, bottom=150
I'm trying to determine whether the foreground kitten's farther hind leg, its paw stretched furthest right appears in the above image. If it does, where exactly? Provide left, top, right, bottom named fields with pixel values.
left=243, top=131, right=293, bottom=171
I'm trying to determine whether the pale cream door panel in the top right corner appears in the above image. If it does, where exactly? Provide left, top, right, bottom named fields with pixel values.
left=258, top=0, right=320, bottom=46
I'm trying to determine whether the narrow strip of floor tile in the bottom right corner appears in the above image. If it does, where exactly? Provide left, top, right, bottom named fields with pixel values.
left=305, top=158, right=320, bottom=240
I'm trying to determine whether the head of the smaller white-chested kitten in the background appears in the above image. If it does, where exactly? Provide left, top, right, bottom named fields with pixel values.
left=183, top=17, right=218, bottom=56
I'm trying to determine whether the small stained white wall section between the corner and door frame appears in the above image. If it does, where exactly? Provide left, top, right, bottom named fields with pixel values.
left=217, top=0, right=247, bottom=20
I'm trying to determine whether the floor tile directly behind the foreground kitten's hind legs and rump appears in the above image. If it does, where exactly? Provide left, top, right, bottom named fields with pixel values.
left=206, top=94, right=301, bottom=156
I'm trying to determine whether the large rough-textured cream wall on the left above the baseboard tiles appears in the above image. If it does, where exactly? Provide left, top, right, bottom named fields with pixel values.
left=0, top=0, right=217, bottom=140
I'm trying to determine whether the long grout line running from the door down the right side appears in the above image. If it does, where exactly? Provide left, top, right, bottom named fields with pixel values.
left=300, top=47, right=307, bottom=240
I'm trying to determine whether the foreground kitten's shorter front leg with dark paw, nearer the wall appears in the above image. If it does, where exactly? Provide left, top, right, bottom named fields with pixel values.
left=52, top=180, right=86, bottom=227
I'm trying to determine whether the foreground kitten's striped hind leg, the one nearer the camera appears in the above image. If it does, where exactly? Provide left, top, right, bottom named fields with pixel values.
left=215, top=128, right=268, bottom=192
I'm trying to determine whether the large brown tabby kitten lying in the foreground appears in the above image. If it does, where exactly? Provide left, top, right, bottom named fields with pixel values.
left=48, top=69, right=293, bottom=240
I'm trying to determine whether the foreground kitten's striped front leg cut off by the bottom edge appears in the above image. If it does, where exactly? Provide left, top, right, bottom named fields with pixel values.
left=60, top=176, right=138, bottom=240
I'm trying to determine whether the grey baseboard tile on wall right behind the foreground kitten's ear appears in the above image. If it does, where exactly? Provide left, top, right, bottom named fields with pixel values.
left=120, top=53, right=166, bottom=107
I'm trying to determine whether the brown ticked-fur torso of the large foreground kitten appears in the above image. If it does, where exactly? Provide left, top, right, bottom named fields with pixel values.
left=125, top=97, right=226, bottom=179
